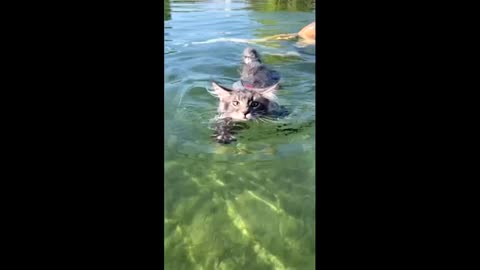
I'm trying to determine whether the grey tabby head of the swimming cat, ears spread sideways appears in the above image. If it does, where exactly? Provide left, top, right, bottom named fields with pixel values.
left=212, top=82, right=278, bottom=121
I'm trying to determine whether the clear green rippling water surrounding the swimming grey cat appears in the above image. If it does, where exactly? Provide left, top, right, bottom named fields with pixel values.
left=164, top=0, right=315, bottom=270
